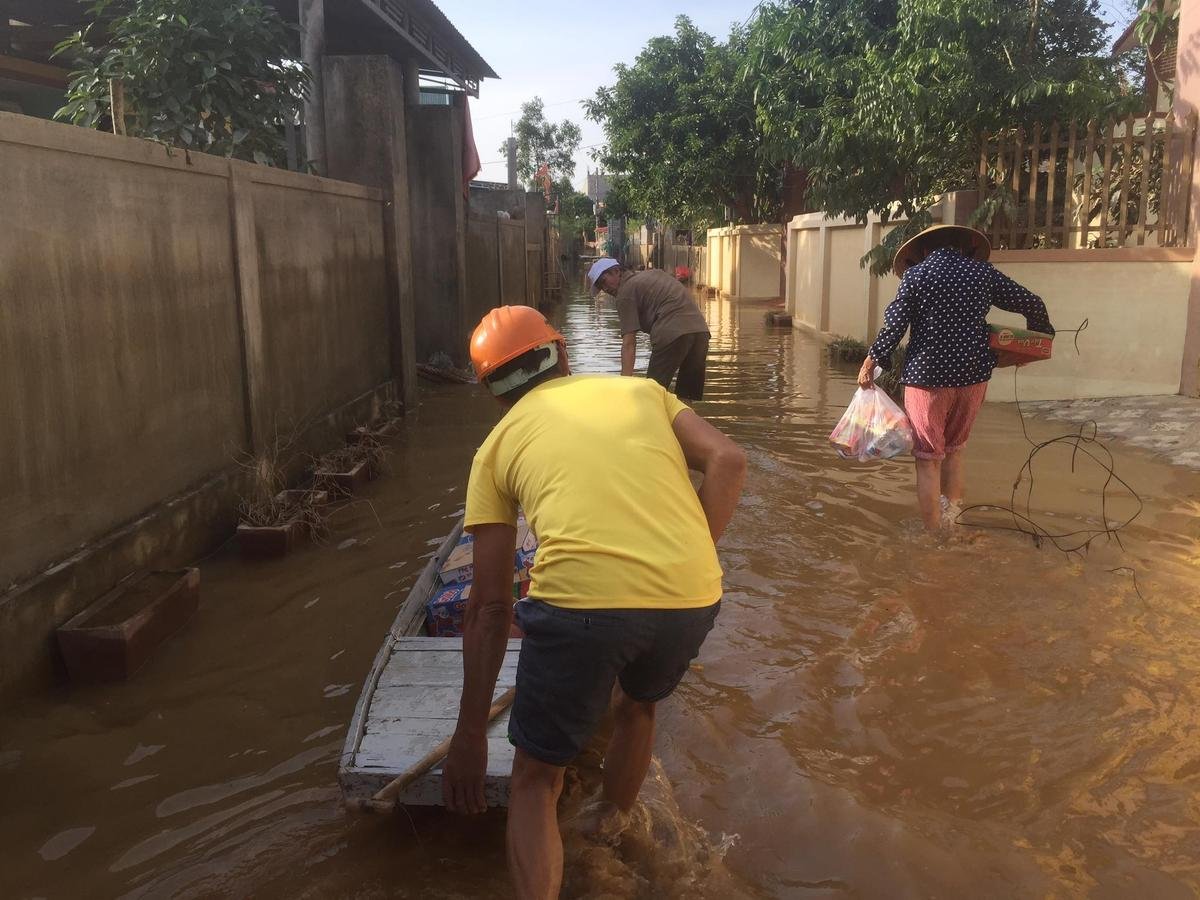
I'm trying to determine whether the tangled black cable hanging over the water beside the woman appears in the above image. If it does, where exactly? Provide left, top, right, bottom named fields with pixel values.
left=955, top=319, right=1145, bottom=556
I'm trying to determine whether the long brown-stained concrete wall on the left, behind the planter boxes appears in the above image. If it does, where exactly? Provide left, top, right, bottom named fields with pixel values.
left=0, top=114, right=394, bottom=694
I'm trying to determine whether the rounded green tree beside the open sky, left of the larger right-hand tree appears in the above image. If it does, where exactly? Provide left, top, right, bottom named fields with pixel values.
left=584, top=16, right=779, bottom=227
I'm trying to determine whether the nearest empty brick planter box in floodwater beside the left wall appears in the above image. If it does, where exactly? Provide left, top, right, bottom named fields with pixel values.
left=58, top=569, right=200, bottom=683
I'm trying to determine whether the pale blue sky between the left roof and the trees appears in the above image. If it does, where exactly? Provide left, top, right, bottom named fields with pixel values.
left=436, top=0, right=1130, bottom=191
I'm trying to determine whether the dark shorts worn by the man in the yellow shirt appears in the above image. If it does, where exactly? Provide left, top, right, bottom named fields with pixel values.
left=509, top=600, right=721, bottom=766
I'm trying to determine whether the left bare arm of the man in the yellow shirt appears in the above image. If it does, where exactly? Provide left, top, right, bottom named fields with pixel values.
left=442, top=524, right=517, bottom=814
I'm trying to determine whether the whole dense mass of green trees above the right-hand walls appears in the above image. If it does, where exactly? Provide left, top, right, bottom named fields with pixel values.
left=584, top=0, right=1145, bottom=259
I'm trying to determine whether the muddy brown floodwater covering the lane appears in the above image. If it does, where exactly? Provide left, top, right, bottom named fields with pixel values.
left=0, top=282, right=1200, bottom=898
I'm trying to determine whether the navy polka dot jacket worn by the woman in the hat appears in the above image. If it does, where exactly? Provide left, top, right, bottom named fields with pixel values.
left=870, top=247, right=1054, bottom=388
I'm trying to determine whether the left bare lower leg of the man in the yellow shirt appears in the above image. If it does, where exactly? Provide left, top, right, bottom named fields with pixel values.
left=508, top=748, right=563, bottom=900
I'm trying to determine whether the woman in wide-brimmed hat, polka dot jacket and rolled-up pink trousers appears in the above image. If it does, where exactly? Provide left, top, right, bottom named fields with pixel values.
left=858, top=226, right=1054, bottom=529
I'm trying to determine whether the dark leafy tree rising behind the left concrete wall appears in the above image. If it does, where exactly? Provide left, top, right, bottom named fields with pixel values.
left=56, top=0, right=310, bottom=164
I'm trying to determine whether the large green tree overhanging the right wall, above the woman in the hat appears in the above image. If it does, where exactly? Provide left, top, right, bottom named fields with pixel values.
left=744, top=0, right=1140, bottom=270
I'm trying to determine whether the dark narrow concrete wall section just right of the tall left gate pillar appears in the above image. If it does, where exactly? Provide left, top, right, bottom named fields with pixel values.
left=408, top=99, right=469, bottom=366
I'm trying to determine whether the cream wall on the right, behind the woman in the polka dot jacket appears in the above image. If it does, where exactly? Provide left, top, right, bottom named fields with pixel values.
left=787, top=196, right=1193, bottom=401
